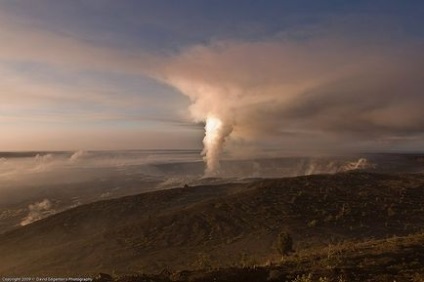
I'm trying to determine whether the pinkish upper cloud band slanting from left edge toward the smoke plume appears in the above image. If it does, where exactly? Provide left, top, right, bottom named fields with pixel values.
left=0, top=11, right=155, bottom=74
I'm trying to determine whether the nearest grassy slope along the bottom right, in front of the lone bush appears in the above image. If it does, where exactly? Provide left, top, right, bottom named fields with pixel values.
left=117, top=233, right=424, bottom=282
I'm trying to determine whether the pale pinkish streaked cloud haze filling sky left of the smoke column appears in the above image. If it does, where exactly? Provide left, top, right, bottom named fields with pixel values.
left=0, top=10, right=198, bottom=150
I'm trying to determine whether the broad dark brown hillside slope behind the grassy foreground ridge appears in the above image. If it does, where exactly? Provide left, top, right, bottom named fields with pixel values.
left=0, top=173, right=424, bottom=276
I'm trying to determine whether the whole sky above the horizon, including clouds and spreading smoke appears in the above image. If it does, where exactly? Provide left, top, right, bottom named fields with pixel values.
left=0, top=0, right=424, bottom=155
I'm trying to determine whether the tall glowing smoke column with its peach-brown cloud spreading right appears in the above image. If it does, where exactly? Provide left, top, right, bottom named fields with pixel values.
left=160, top=36, right=424, bottom=174
